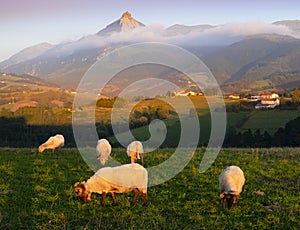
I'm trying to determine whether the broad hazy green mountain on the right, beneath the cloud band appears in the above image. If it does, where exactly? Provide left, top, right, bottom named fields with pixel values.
left=203, top=34, right=300, bottom=92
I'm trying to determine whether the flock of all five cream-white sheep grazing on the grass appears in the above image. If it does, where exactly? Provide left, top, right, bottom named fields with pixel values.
left=38, top=134, right=245, bottom=209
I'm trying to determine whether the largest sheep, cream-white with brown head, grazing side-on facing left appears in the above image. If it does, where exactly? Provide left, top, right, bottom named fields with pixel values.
left=74, top=163, right=148, bottom=206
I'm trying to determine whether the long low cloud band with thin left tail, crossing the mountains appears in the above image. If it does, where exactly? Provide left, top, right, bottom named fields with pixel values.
left=37, top=23, right=300, bottom=57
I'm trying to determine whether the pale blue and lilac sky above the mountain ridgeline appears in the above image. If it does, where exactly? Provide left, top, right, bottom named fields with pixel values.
left=0, top=0, right=300, bottom=62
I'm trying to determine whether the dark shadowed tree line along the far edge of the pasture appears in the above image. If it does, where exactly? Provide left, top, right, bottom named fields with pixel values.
left=0, top=117, right=300, bottom=148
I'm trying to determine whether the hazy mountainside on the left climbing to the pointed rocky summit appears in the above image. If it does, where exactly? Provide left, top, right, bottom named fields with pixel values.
left=0, top=12, right=144, bottom=88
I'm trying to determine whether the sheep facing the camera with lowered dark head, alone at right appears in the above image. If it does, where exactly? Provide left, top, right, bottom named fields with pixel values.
left=219, top=165, right=245, bottom=209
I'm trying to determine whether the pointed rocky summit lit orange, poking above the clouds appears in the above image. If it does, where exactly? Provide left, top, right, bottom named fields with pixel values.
left=97, top=11, right=145, bottom=36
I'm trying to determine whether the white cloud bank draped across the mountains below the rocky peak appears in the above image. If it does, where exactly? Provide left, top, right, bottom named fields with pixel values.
left=87, top=23, right=300, bottom=46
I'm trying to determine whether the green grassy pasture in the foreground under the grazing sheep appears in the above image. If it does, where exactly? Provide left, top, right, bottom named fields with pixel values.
left=0, top=148, right=300, bottom=229
